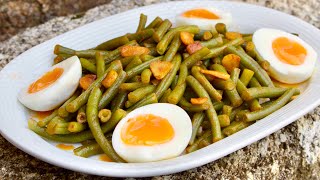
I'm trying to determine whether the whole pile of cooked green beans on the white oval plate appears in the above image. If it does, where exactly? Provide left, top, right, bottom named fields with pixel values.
left=28, top=14, right=300, bottom=162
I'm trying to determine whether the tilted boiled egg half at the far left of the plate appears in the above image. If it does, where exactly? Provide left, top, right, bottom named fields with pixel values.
left=18, top=56, right=82, bottom=111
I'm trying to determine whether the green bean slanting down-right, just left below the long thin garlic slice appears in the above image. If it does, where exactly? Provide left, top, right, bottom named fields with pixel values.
left=191, top=66, right=222, bottom=102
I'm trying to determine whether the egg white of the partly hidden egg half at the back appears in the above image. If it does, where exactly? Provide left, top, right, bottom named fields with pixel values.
left=176, top=7, right=232, bottom=30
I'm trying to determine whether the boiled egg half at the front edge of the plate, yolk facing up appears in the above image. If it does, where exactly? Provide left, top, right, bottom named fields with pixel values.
left=112, top=103, right=192, bottom=162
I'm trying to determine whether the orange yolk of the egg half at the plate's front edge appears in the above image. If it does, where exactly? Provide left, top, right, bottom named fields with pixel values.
left=121, top=114, right=174, bottom=146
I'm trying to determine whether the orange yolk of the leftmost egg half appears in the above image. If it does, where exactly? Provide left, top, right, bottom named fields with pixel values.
left=28, top=68, right=63, bottom=94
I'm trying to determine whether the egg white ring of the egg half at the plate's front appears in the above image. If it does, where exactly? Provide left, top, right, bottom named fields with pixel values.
left=112, top=103, right=192, bottom=162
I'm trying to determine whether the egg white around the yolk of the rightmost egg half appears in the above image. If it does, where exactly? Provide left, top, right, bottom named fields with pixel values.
left=252, top=28, right=317, bottom=84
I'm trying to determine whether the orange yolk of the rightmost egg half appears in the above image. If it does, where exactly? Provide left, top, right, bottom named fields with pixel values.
left=272, top=37, right=307, bottom=65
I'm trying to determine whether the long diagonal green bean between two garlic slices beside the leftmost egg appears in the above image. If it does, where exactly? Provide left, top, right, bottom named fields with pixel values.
left=66, top=60, right=122, bottom=112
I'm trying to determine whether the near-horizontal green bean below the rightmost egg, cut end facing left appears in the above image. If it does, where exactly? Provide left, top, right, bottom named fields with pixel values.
left=243, top=87, right=300, bottom=101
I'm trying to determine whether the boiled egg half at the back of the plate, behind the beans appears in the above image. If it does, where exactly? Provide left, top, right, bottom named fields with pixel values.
left=176, top=7, right=232, bottom=30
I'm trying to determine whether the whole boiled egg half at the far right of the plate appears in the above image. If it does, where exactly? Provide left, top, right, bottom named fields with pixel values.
left=252, top=28, right=317, bottom=84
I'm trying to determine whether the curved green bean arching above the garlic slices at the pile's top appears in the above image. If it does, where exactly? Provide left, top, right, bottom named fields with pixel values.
left=157, top=25, right=200, bottom=55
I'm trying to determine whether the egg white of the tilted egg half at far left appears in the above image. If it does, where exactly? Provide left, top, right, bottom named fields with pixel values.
left=18, top=56, right=82, bottom=111
